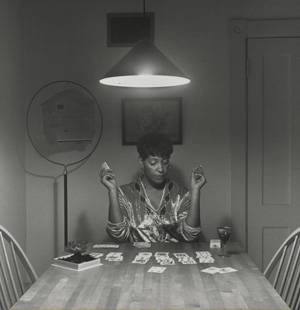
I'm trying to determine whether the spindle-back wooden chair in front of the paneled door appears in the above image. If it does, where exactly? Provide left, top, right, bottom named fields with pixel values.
left=264, top=228, right=300, bottom=310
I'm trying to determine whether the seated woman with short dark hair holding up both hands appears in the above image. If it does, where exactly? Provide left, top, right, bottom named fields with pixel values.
left=100, top=133, right=206, bottom=242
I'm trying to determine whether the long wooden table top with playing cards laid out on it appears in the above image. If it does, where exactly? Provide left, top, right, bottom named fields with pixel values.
left=12, top=242, right=289, bottom=309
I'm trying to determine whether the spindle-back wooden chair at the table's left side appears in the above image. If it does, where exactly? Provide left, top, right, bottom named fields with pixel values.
left=0, top=225, right=37, bottom=310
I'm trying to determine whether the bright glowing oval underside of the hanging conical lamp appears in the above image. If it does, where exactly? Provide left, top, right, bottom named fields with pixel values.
left=100, top=75, right=190, bottom=87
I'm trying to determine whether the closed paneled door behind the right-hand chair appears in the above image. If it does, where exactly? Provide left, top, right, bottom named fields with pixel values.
left=247, top=38, right=300, bottom=270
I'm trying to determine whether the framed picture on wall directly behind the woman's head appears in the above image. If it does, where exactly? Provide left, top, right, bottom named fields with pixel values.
left=122, top=97, right=182, bottom=145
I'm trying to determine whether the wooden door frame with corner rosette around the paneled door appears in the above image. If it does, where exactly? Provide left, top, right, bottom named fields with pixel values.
left=229, top=19, right=300, bottom=251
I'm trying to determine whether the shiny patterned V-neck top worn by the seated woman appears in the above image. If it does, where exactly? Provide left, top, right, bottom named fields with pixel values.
left=107, top=179, right=201, bottom=242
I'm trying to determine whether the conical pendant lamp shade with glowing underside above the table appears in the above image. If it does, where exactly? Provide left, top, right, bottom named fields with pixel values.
left=100, top=40, right=190, bottom=87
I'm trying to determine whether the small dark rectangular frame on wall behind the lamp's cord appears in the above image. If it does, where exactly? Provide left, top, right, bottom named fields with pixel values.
left=107, top=12, right=154, bottom=47
